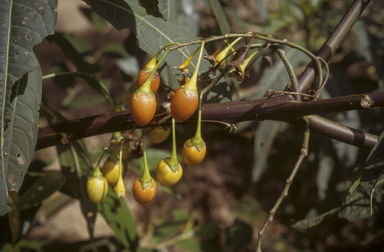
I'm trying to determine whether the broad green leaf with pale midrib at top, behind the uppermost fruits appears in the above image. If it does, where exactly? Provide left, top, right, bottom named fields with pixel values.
left=85, top=0, right=209, bottom=74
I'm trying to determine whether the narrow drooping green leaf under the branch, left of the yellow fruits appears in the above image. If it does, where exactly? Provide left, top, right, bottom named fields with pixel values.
left=56, top=140, right=96, bottom=240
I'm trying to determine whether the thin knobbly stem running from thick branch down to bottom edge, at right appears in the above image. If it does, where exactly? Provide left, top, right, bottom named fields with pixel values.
left=256, top=117, right=310, bottom=252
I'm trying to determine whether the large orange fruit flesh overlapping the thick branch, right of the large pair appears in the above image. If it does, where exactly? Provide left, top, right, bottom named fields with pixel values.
left=171, top=88, right=199, bottom=122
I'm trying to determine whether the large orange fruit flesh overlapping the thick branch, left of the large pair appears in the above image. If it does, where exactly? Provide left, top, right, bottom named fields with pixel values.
left=131, top=92, right=156, bottom=126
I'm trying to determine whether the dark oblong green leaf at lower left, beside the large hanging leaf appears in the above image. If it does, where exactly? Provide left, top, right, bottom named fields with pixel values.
left=17, top=171, right=65, bottom=210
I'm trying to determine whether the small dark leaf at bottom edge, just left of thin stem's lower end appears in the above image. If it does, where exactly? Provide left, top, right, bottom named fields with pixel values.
left=225, top=219, right=253, bottom=251
